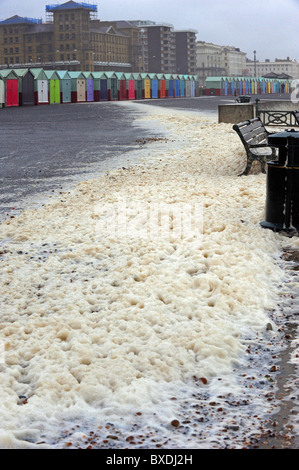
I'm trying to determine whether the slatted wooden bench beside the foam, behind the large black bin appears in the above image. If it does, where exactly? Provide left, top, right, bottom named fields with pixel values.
left=233, top=117, right=276, bottom=176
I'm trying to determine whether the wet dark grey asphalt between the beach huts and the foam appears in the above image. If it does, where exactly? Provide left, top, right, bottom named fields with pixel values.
left=0, top=102, right=159, bottom=220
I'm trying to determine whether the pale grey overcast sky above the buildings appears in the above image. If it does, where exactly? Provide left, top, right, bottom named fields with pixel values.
left=0, top=0, right=299, bottom=62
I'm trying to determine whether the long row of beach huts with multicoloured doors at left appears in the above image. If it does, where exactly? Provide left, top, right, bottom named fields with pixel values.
left=0, top=68, right=199, bottom=108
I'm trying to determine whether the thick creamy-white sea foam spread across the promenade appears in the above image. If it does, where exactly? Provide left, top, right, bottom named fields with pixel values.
left=0, top=104, right=298, bottom=448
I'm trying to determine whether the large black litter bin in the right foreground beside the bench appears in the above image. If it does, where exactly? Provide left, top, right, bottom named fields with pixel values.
left=261, top=130, right=299, bottom=232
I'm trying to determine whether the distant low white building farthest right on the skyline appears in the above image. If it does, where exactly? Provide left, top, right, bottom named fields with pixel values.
left=246, top=57, right=299, bottom=79
